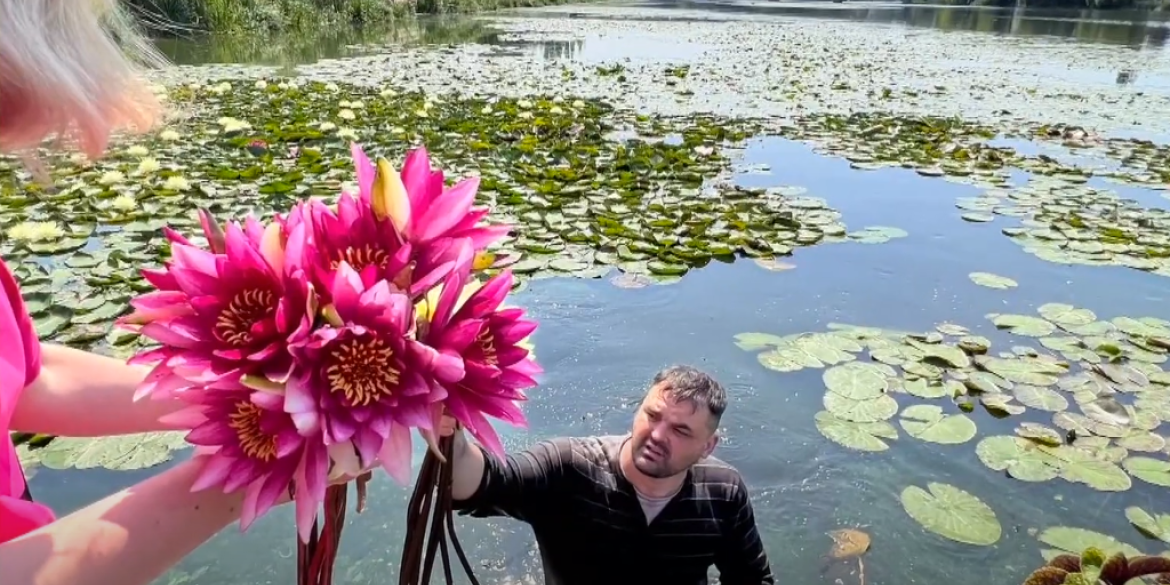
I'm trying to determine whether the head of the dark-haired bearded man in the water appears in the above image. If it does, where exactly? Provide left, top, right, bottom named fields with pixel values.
left=629, top=365, right=728, bottom=479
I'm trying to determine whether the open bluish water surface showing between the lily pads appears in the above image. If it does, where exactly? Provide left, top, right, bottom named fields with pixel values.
left=25, top=2, right=1170, bottom=585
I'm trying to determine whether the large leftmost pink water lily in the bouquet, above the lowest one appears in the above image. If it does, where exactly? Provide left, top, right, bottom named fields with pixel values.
left=119, top=218, right=315, bottom=398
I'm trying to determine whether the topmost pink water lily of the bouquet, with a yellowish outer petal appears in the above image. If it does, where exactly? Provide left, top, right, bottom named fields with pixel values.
left=350, top=143, right=510, bottom=250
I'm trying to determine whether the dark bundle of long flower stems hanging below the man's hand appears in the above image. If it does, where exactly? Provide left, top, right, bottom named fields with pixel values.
left=398, top=436, right=480, bottom=585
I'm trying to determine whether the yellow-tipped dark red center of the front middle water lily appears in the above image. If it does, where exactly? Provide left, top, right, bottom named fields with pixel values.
left=325, top=336, right=402, bottom=406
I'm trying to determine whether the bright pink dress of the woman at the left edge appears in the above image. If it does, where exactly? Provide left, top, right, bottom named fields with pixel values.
left=0, top=260, right=53, bottom=543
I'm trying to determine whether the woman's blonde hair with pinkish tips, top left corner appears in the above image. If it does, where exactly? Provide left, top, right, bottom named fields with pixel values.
left=0, top=0, right=166, bottom=157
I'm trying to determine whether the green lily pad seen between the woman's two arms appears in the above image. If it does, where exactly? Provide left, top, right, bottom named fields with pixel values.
left=37, top=432, right=187, bottom=472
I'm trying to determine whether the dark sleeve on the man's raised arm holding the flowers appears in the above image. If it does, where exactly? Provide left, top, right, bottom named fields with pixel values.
left=452, top=439, right=572, bottom=522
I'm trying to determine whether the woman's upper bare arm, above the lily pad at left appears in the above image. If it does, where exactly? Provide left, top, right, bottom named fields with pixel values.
left=11, top=343, right=183, bottom=436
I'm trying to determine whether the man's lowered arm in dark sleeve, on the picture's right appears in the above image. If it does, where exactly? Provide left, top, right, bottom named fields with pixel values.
left=715, top=480, right=776, bottom=585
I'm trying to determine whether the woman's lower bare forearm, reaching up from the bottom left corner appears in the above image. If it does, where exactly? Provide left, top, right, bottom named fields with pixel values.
left=0, top=461, right=243, bottom=585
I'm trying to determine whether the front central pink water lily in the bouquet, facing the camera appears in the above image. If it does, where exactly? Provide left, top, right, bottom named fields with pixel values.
left=284, top=262, right=446, bottom=483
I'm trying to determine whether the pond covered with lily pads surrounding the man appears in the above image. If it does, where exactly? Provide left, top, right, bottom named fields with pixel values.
left=0, top=2, right=1170, bottom=585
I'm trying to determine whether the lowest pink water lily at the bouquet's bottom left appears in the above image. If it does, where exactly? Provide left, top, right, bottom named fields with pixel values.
left=168, top=386, right=328, bottom=530
